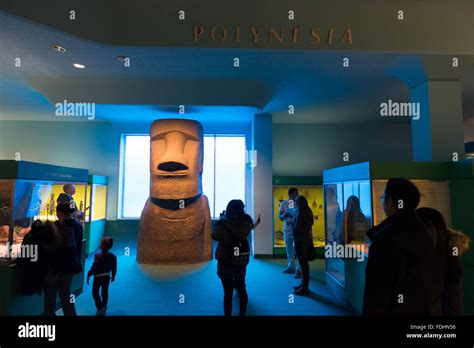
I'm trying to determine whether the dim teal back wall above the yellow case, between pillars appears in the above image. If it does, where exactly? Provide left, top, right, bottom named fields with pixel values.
left=273, top=124, right=411, bottom=176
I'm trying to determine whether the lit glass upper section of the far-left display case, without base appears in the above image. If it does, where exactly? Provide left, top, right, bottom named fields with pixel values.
left=0, top=160, right=87, bottom=259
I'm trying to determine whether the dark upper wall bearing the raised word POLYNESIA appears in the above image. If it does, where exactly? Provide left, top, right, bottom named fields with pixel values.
left=0, top=0, right=474, bottom=54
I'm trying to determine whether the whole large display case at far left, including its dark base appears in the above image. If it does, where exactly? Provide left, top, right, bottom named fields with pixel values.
left=0, top=160, right=88, bottom=314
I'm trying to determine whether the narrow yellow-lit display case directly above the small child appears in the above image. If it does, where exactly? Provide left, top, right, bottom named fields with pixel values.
left=84, top=175, right=107, bottom=254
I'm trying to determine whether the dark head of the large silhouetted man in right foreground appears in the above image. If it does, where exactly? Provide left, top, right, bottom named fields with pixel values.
left=382, top=178, right=420, bottom=216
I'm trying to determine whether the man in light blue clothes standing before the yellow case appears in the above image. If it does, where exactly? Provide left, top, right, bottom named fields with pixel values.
left=278, top=187, right=301, bottom=278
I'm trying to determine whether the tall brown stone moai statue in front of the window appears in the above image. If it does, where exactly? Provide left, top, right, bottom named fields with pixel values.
left=137, top=119, right=212, bottom=264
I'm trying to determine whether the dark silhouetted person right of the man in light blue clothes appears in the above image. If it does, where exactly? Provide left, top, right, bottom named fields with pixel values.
left=293, top=196, right=314, bottom=295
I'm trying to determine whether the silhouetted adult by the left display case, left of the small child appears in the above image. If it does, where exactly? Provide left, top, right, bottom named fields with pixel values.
left=44, top=200, right=84, bottom=316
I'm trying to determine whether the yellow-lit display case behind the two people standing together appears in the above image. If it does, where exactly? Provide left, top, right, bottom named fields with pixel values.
left=273, top=176, right=325, bottom=255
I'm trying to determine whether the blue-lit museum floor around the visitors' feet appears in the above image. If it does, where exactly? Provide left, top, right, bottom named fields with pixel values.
left=58, top=255, right=350, bottom=315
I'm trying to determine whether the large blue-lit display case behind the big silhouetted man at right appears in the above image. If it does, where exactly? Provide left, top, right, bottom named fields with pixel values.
left=323, top=161, right=474, bottom=312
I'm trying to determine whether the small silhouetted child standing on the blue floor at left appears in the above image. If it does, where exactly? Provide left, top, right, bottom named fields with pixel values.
left=87, top=237, right=117, bottom=315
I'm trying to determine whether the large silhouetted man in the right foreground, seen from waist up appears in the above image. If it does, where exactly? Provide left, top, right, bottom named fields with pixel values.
left=363, top=179, right=439, bottom=315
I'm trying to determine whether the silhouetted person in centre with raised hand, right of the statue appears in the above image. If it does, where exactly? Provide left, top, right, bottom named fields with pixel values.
left=212, top=199, right=260, bottom=316
